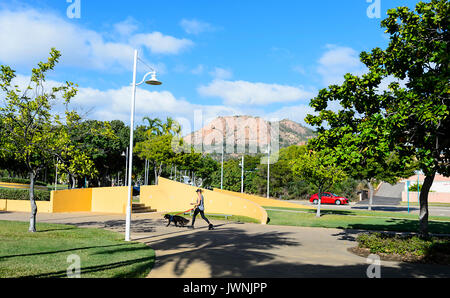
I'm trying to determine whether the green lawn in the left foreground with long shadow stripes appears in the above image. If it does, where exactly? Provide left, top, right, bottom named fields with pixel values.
left=0, top=221, right=155, bottom=278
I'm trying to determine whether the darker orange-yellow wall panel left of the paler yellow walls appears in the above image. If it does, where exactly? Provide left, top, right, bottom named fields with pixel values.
left=50, top=188, right=92, bottom=212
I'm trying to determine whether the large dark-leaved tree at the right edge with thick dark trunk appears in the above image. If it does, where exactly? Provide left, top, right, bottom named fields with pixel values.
left=307, top=0, right=450, bottom=236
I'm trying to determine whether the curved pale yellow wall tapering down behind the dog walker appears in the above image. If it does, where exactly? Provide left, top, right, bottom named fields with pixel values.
left=140, top=177, right=267, bottom=224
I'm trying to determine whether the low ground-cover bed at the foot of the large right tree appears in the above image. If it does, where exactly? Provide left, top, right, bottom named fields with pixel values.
left=352, top=233, right=450, bottom=265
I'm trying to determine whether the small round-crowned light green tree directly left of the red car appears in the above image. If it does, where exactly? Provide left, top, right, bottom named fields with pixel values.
left=291, top=151, right=346, bottom=217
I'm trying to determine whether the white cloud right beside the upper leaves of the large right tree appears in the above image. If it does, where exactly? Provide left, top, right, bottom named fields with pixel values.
left=317, top=45, right=366, bottom=86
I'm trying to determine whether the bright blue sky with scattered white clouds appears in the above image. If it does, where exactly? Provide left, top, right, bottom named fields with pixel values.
left=0, top=0, right=418, bottom=131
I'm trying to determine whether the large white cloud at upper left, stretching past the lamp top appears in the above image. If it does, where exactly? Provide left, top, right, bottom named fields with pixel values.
left=0, top=9, right=193, bottom=70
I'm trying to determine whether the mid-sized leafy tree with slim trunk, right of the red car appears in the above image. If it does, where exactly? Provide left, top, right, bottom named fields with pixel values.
left=306, top=92, right=417, bottom=210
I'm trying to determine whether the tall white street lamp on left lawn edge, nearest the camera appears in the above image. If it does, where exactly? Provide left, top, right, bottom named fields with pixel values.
left=125, top=50, right=162, bottom=241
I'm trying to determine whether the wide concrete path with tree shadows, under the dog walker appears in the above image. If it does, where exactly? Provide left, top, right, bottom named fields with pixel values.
left=0, top=212, right=450, bottom=278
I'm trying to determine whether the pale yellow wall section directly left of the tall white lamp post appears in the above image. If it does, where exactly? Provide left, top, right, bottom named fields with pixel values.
left=91, top=186, right=128, bottom=214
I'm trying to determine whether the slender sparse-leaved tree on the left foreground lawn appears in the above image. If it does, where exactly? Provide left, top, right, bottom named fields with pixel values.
left=0, top=49, right=77, bottom=232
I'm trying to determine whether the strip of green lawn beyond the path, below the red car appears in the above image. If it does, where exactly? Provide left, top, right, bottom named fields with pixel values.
left=266, top=207, right=450, bottom=234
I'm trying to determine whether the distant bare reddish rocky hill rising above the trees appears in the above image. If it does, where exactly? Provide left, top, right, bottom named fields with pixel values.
left=183, top=116, right=314, bottom=152
